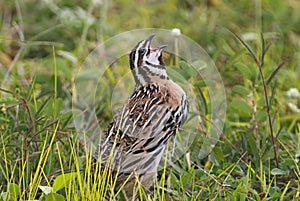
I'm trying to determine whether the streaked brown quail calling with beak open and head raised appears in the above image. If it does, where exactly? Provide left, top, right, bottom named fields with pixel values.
left=94, top=34, right=189, bottom=197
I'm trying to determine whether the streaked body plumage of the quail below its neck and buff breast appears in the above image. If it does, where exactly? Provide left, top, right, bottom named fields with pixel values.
left=95, top=82, right=188, bottom=174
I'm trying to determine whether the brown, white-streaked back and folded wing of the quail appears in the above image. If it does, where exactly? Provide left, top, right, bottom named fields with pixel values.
left=96, top=85, right=168, bottom=164
